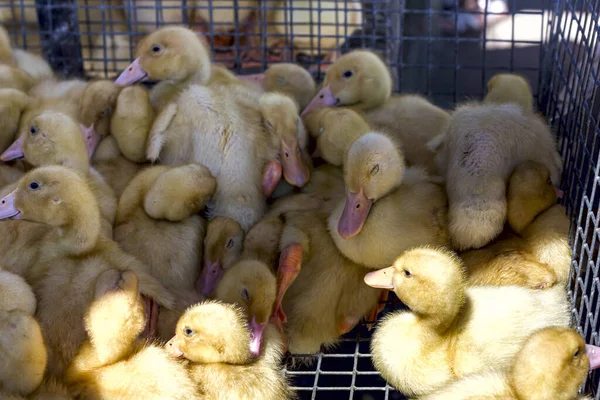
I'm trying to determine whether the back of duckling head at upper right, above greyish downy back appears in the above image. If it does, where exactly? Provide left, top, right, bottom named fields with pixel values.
left=483, top=74, right=533, bottom=114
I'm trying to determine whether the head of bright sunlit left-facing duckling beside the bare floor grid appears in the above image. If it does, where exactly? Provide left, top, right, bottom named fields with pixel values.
left=365, top=247, right=465, bottom=327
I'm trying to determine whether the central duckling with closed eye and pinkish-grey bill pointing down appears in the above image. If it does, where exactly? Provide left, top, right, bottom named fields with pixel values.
left=329, top=132, right=449, bottom=268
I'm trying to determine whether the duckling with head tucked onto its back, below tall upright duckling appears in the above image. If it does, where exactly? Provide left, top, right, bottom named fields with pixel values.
left=114, top=165, right=216, bottom=340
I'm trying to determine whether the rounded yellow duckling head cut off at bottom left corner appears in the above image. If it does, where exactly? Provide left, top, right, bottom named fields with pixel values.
left=0, top=310, right=48, bottom=396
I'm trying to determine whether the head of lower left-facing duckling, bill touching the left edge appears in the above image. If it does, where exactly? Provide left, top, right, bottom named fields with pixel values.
left=0, top=166, right=100, bottom=233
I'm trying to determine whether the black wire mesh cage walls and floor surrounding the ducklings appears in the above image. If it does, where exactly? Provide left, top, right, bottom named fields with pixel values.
left=0, top=0, right=600, bottom=400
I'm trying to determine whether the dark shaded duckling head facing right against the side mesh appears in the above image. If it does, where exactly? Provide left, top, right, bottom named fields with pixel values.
left=506, top=161, right=562, bottom=233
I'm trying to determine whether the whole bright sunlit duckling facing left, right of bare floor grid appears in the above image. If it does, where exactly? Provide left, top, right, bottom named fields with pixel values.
left=365, top=247, right=569, bottom=395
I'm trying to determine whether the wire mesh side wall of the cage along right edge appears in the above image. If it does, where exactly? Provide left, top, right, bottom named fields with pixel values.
left=542, top=0, right=600, bottom=399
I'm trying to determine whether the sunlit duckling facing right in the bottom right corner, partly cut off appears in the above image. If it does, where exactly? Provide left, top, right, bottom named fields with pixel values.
left=422, top=326, right=600, bottom=400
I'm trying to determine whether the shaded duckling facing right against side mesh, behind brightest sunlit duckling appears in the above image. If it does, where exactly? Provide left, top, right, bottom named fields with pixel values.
left=460, top=161, right=571, bottom=289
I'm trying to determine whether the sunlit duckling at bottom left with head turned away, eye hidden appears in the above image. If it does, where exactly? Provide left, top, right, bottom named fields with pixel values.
left=65, top=269, right=202, bottom=400
